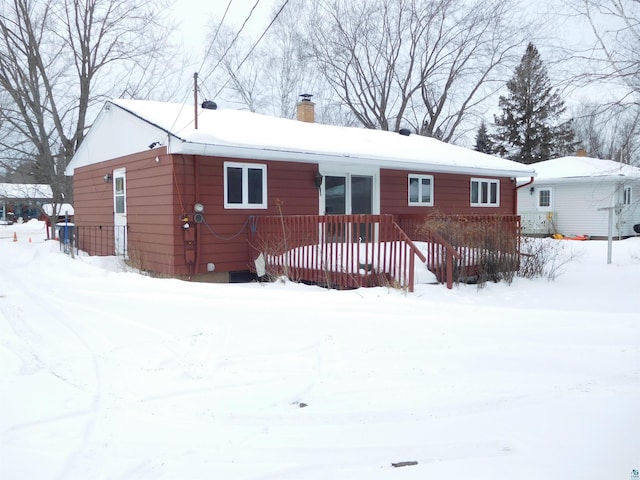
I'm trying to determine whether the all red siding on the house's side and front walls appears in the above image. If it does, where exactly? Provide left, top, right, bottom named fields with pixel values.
left=74, top=149, right=515, bottom=276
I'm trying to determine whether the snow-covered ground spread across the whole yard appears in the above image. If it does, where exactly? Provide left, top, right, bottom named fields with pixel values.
left=0, top=222, right=640, bottom=480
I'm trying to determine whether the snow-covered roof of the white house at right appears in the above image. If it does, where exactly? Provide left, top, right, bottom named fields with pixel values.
left=533, top=157, right=640, bottom=183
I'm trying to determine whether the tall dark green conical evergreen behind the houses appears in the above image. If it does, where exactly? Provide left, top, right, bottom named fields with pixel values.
left=494, top=43, right=576, bottom=164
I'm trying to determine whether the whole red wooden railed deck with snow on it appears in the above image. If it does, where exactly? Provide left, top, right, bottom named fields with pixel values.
left=249, top=215, right=519, bottom=291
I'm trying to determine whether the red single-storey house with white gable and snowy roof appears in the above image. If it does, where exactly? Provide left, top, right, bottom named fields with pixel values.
left=67, top=98, right=534, bottom=288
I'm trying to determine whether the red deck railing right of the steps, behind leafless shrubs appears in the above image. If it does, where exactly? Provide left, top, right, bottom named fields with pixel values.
left=398, top=215, right=520, bottom=288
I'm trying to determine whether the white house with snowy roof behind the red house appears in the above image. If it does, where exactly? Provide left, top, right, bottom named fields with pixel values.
left=518, top=157, right=640, bottom=238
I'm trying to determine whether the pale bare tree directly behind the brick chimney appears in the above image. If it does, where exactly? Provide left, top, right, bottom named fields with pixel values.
left=200, top=0, right=329, bottom=118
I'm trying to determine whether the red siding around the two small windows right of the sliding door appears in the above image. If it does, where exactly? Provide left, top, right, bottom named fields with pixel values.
left=380, top=169, right=516, bottom=215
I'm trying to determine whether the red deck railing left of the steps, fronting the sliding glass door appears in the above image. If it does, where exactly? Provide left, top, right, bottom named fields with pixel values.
left=249, top=215, right=426, bottom=291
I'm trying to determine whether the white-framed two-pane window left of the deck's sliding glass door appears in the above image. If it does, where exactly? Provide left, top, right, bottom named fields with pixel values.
left=224, top=162, right=267, bottom=208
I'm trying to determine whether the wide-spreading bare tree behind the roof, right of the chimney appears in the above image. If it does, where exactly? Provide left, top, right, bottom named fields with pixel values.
left=309, top=0, right=527, bottom=141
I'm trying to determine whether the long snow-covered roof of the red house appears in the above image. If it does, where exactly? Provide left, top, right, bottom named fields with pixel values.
left=74, top=100, right=535, bottom=177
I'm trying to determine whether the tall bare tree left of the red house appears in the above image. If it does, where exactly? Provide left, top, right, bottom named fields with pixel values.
left=0, top=0, right=178, bottom=214
